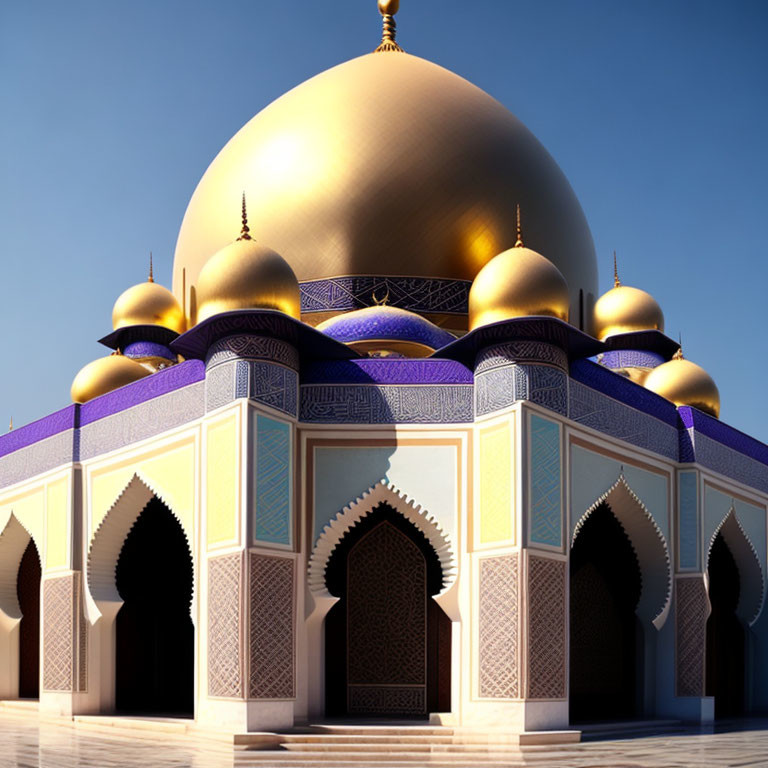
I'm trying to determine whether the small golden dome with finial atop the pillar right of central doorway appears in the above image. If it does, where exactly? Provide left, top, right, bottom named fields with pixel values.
left=469, top=210, right=569, bottom=330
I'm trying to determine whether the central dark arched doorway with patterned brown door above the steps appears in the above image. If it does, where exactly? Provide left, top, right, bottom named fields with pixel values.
left=325, top=504, right=451, bottom=718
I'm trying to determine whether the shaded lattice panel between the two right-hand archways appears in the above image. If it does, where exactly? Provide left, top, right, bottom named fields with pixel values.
left=675, top=575, right=709, bottom=696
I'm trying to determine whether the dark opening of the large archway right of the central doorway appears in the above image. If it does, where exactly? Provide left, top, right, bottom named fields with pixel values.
left=569, top=504, right=643, bottom=722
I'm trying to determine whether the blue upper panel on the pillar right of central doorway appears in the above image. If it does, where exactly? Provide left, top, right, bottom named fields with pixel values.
left=530, top=413, right=562, bottom=547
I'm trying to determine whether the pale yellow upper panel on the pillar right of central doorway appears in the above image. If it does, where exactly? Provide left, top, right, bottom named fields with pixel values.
left=479, top=422, right=514, bottom=544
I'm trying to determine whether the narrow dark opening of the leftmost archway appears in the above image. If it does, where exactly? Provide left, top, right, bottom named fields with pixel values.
left=16, top=539, right=40, bottom=699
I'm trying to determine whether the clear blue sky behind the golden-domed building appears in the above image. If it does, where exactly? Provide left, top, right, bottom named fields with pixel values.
left=0, top=0, right=768, bottom=441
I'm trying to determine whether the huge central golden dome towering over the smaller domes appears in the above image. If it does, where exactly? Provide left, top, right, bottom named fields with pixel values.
left=173, top=52, right=597, bottom=330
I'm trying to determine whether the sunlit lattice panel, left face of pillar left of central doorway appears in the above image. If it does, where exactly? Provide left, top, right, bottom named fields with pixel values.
left=208, top=553, right=243, bottom=699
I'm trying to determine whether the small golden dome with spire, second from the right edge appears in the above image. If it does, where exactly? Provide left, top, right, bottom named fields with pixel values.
left=594, top=253, right=664, bottom=341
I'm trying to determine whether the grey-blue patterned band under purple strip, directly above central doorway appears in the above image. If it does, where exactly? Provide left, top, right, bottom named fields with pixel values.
left=300, top=384, right=474, bottom=424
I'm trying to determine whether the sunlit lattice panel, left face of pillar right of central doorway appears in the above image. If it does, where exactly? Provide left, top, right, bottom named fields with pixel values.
left=478, top=555, right=520, bottom=699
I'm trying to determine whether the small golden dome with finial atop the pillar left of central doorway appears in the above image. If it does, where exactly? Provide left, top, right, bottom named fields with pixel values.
left=195, top=196, right=301, bottom=323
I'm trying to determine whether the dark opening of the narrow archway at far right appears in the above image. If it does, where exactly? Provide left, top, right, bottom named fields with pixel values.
left=706, top=533, right=745, bottom=717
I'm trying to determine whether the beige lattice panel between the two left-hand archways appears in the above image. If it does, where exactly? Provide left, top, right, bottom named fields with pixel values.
left=43, top=574, right=77, bottom=691
